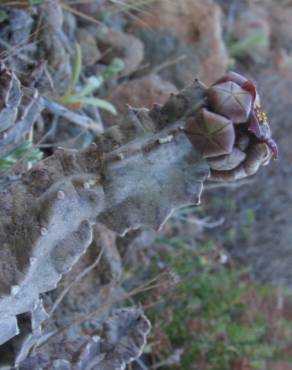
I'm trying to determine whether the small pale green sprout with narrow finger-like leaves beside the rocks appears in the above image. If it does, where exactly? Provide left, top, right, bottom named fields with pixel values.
left=59, top=44, right=124, bottom=114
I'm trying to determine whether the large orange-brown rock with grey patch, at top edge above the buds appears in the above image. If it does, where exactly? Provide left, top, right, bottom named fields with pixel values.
left=132, top=0, right=228, bottom=87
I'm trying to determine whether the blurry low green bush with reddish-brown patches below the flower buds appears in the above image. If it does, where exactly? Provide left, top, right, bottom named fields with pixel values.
left=141, top=239, right=287, bottom=370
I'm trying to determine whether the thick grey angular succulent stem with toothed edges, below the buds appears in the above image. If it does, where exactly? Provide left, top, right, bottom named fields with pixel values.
left=0, top=82, right=209, bottom=344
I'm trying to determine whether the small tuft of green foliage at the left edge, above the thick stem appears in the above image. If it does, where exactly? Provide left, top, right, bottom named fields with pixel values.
left=0, top=140, right=43, bottom=172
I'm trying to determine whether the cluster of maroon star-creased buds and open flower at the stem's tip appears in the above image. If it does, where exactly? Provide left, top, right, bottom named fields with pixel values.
left=185, top=72, right=278, bottom=181
